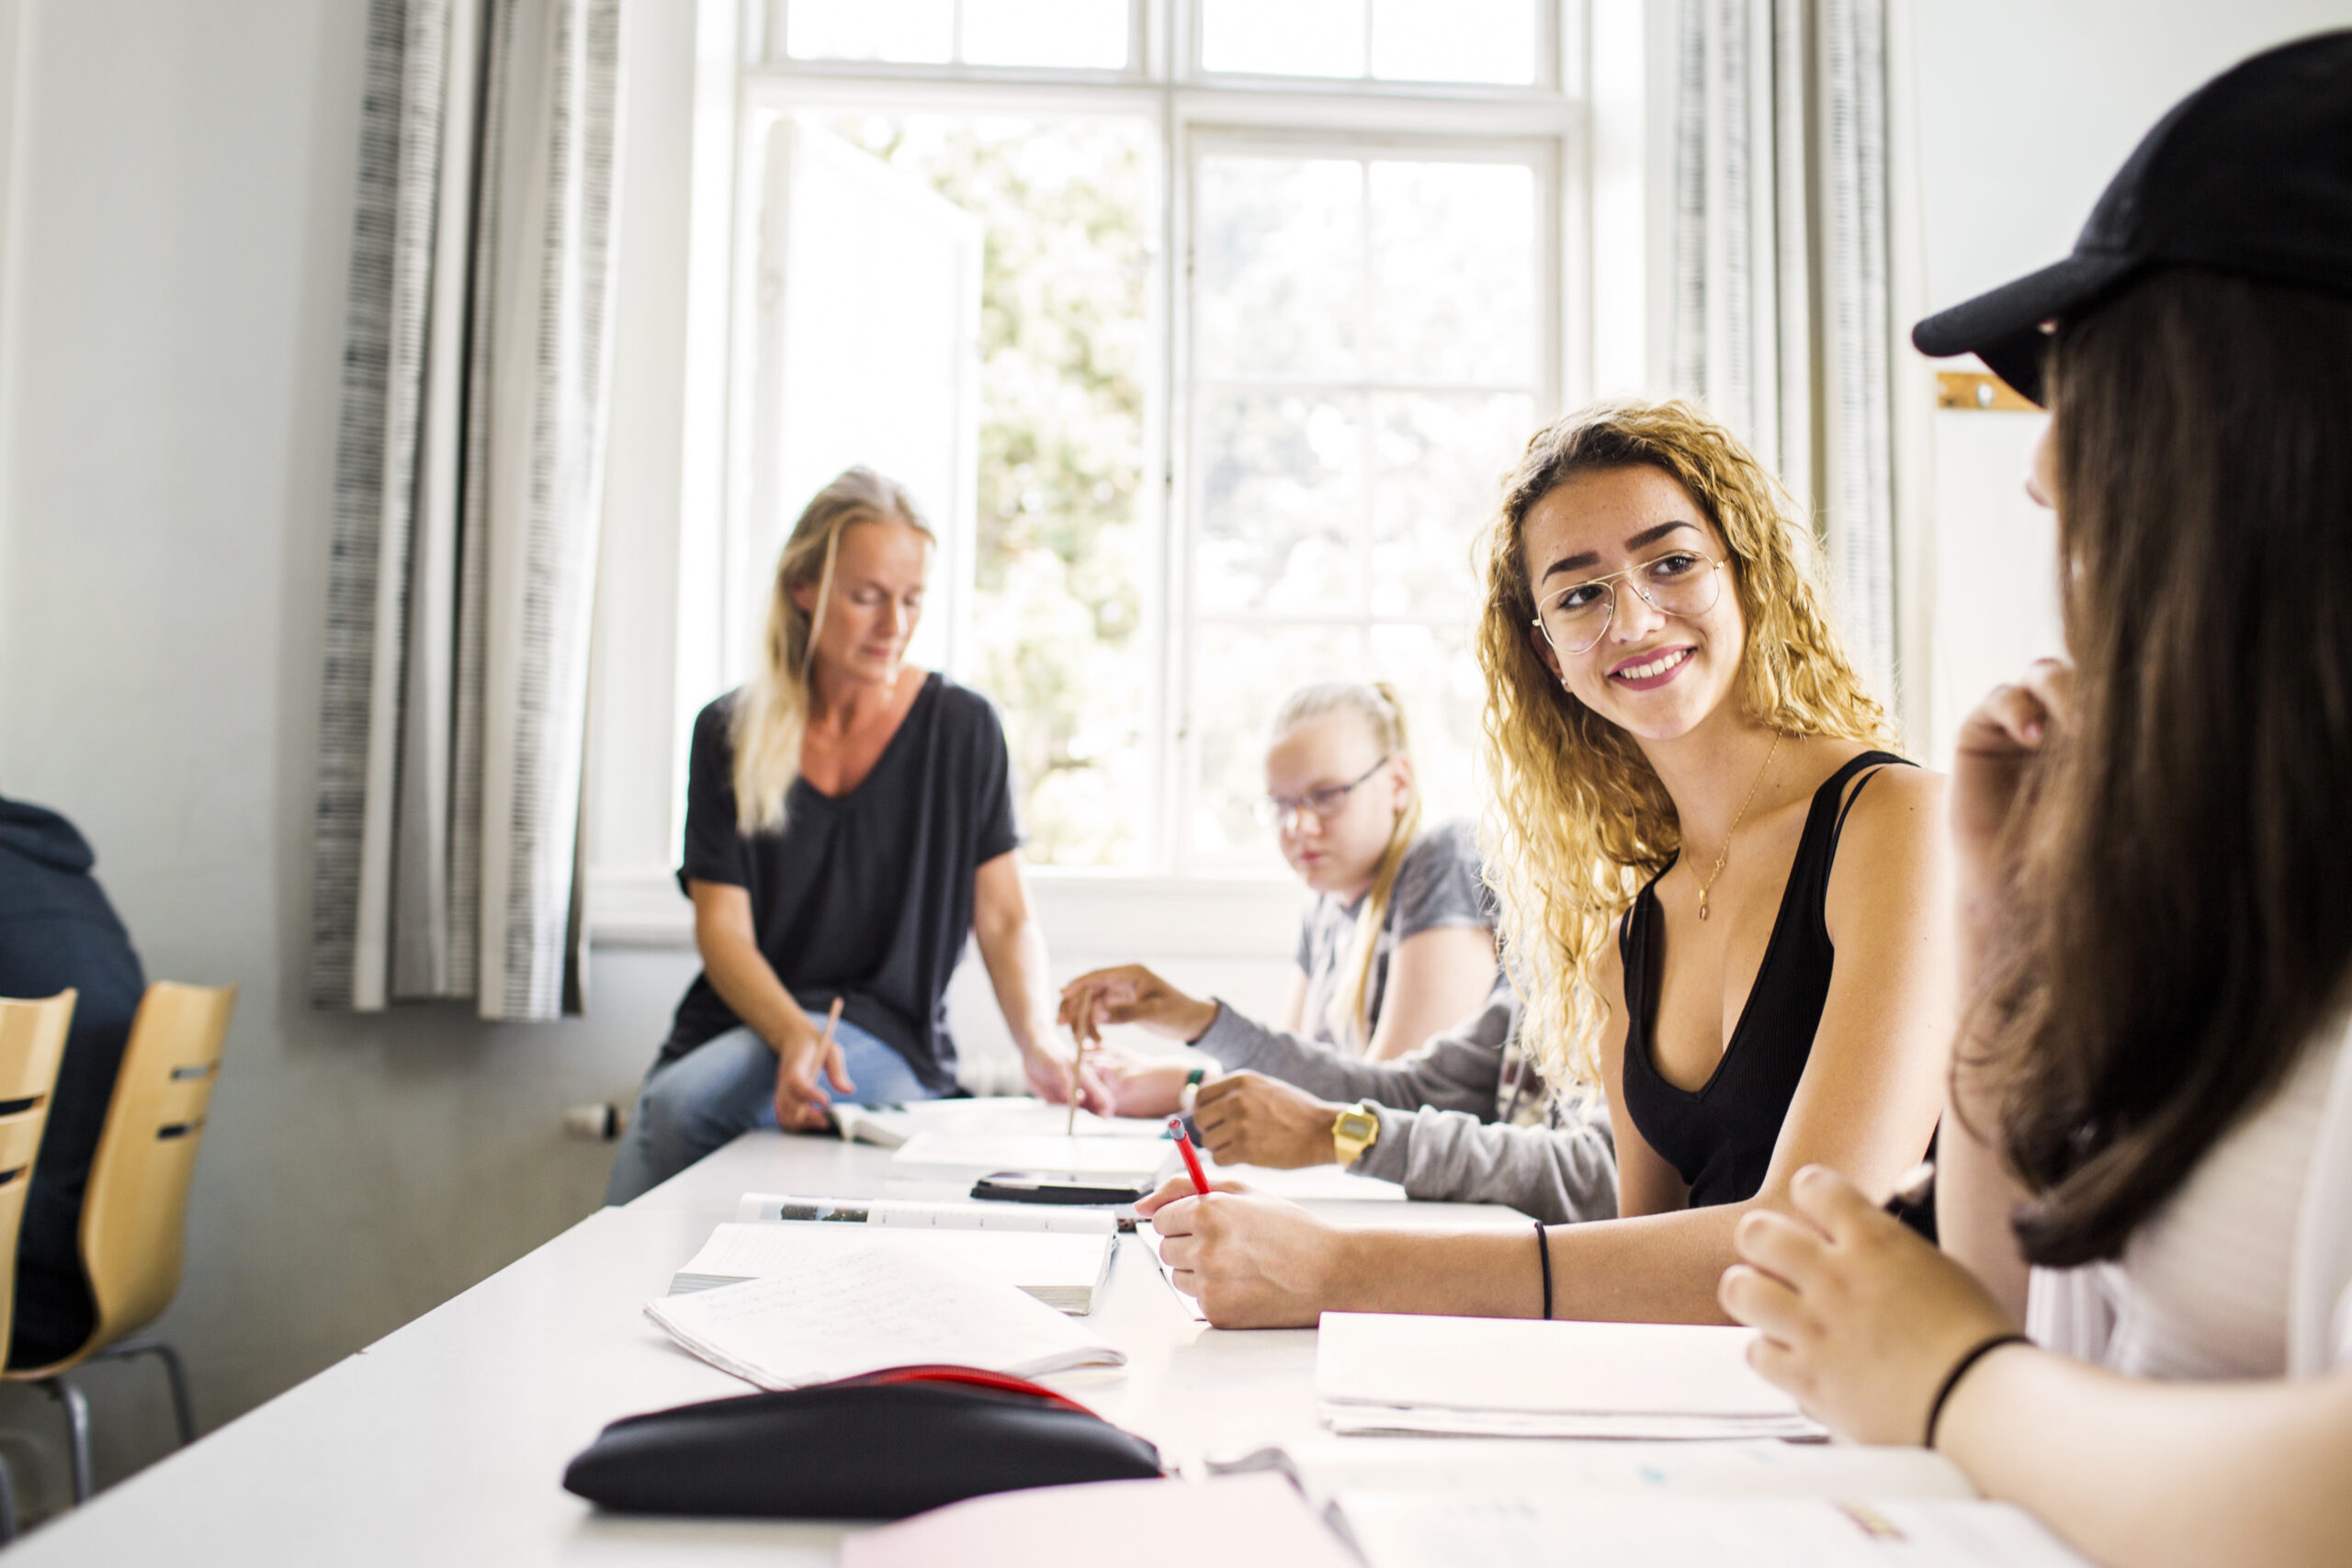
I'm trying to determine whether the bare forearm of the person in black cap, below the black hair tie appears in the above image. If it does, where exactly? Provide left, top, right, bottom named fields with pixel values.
left=1936, top=1347, right=2352, bottom=1568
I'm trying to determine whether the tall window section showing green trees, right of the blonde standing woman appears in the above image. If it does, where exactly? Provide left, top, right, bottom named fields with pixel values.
left=837, top=115, right=1158, bottom=865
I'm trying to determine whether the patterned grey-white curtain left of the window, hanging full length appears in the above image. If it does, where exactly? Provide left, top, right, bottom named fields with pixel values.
left=311, top=0, right=623, bottom=1018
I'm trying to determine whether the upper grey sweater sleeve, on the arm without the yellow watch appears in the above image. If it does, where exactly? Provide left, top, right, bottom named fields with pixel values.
left=1193, top=985, right=1517, bottom=1123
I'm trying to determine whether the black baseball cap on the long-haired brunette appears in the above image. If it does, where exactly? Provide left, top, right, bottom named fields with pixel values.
left=1912, top=30, right=2352, bottom=402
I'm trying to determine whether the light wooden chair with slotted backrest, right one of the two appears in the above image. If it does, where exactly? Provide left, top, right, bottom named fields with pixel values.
left=7, top=980, right=238, bottom=1502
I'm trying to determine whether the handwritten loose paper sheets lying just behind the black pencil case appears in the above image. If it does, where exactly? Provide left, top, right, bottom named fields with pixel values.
left=644, top=1227, right=1126, bottom=1389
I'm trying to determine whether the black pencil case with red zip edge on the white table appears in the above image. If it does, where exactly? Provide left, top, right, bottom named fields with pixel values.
left=564, top=1366, right=1159, bottom=1518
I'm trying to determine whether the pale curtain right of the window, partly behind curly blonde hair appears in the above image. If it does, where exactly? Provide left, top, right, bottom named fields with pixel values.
left=1670, top=0, right=1895, bottom=698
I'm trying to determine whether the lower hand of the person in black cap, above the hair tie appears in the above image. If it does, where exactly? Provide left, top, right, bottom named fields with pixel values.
left=1717, top=1166, right=2016, bottom=1443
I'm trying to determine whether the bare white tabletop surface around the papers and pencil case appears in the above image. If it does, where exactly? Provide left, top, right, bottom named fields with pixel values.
left=7, top=1134, right=1529, bottom=1568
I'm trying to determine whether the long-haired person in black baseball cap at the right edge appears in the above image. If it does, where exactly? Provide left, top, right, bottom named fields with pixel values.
left=1719, top=33, right=2352, bottom=1568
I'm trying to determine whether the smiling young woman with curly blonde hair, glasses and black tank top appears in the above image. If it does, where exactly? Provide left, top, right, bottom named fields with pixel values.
left=1138, top=402, right=1952, bottom=1325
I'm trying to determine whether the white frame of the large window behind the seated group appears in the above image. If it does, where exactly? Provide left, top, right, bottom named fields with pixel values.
left=724, top=0, right=1592, bottom=886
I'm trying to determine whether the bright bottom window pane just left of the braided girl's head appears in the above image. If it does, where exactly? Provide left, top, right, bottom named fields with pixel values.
left=1188, top=626, right=1364, bottom=870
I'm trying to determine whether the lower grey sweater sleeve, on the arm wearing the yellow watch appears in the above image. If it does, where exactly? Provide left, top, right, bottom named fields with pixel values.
left=1348, top=1107, right=1616, bottom=1224
